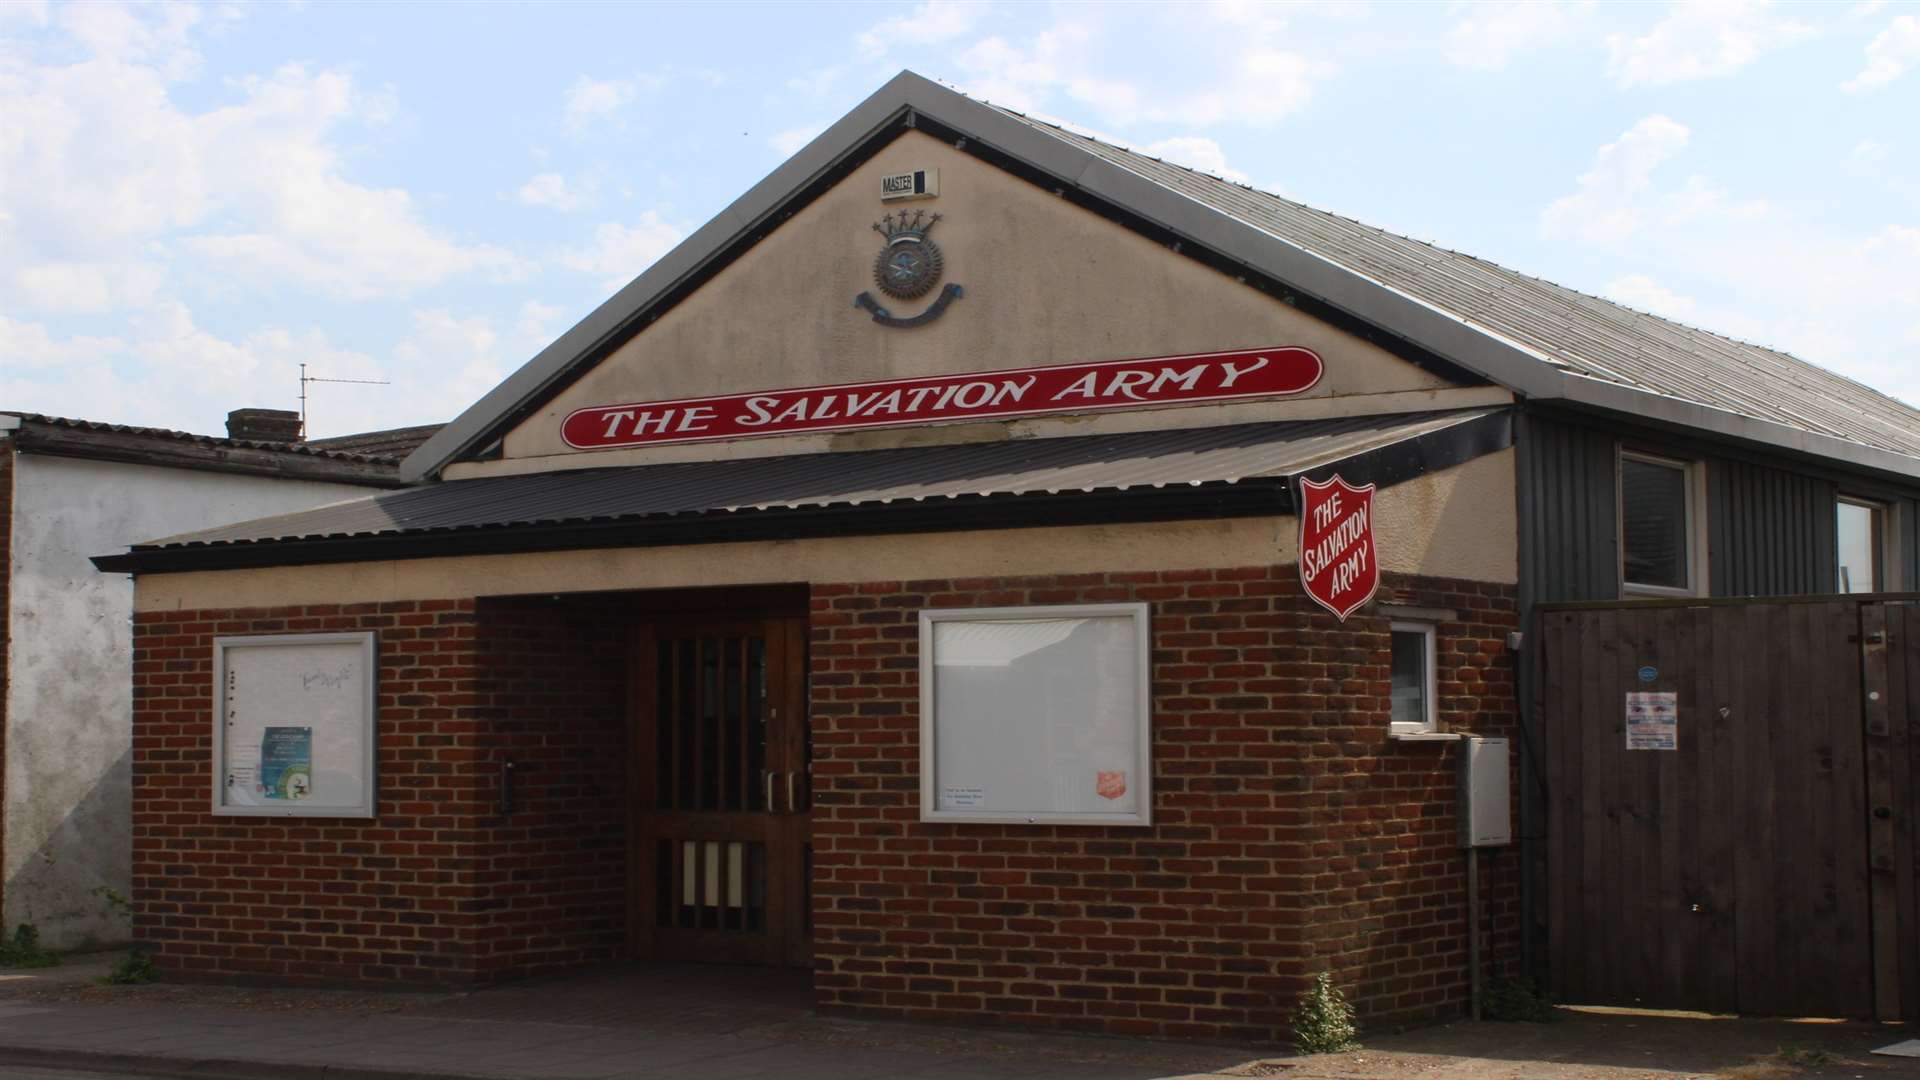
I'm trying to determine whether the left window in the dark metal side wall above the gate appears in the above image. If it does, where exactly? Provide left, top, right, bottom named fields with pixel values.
left=1619, top=450, right=1707, bottom=596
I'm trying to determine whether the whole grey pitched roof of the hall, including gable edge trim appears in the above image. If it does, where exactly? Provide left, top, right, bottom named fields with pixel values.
left=401, top=71, right=1920, bottom=480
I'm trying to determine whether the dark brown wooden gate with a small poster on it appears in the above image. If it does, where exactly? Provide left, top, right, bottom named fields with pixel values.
left=1538, top=596, right=1920, bottom=1019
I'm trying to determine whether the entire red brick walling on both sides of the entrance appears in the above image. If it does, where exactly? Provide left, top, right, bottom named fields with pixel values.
left=134, top=567, right=1517, bottom=1038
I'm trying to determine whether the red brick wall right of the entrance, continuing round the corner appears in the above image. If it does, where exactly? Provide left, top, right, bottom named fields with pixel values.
left=812, top=567, right=1517, bottom=1038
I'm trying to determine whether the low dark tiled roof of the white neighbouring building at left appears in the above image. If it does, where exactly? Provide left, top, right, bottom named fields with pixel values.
left=0, top=411, right=419, bottom=488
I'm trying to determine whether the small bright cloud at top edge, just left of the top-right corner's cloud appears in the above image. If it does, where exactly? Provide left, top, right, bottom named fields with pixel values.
left=1607, top=0, right=1812, bottom=88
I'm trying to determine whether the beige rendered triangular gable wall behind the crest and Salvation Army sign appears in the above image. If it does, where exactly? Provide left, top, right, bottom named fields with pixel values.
left=468, top=133, right=1505, bottom=479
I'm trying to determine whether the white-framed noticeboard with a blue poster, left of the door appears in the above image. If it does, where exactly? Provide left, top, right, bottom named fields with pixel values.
left=213, top=632, right=378, bottom=817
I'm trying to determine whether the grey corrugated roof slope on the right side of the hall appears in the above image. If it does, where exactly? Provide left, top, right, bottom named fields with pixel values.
left=991, top=106, right=1920, bottom=455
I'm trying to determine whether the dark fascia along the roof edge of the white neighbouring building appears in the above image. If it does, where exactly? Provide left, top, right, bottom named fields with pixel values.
left=10, top=419, right=401, bottom=488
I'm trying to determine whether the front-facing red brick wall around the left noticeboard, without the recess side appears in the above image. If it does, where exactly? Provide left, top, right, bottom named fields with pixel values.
left=132, top=600, right=493, bottom=984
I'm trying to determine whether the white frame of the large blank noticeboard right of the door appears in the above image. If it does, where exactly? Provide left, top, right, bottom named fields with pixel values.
left=918, top=601, right=1154, bottom=826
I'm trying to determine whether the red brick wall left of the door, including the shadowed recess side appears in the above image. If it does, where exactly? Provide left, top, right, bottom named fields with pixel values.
left=134, top=600, right=626, bottom=984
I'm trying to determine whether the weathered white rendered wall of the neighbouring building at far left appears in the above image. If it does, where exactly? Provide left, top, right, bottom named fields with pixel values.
left=0, top=442, right=372, bottom=949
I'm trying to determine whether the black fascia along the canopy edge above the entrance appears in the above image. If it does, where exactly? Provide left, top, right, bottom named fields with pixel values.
left=92, top=409, right=1513, bottom=573
